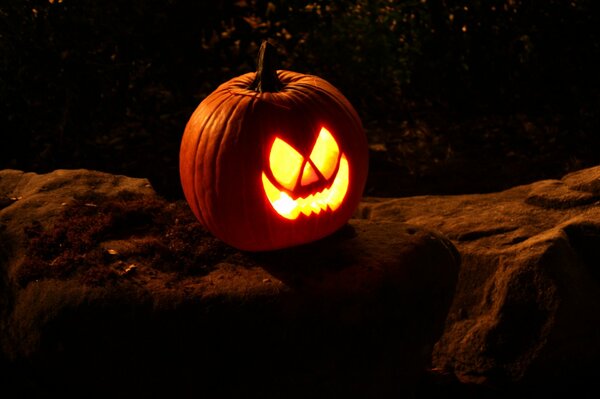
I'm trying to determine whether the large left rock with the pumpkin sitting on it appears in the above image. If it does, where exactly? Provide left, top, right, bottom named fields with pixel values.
left=0, top=170, right=459, bottom=398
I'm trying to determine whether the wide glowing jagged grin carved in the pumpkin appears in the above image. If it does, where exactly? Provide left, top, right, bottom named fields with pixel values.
left=262, top=154, right=350, bottom=220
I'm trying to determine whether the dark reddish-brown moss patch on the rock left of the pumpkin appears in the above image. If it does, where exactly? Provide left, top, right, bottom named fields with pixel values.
left=15, top=193, right=235, bottom=287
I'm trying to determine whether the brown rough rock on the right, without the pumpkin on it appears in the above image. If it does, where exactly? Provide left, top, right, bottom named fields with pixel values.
left=357, top=167, right=600, bottom=397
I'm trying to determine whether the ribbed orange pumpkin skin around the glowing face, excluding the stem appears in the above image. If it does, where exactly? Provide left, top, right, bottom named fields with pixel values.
left=180, top=70, right=368, bottom=251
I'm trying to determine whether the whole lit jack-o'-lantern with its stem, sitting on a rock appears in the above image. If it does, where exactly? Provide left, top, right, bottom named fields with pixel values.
left=180, top=42, right=368, bottom=251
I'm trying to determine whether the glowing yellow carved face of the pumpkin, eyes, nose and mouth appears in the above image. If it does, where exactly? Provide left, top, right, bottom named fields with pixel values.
left=262, top=127, right=350, bottom=220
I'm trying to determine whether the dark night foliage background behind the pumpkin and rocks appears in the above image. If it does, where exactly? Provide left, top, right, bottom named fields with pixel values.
left=0, top=0, right=600, bottom=198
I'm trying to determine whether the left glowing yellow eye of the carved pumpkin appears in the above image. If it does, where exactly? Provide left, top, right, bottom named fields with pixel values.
left=269, top=137, right=304, bottom=190
